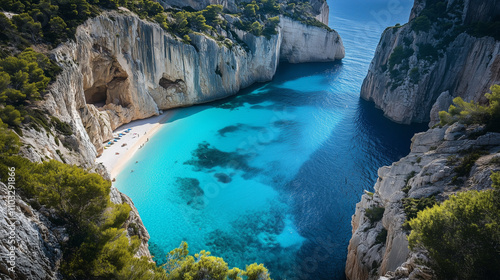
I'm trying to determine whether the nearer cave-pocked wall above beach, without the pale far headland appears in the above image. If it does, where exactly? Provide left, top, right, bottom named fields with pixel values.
left=73, top=13, right=281, bottom=151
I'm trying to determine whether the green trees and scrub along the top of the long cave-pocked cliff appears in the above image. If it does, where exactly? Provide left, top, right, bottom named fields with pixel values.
left=0, top=0, right=328, bottom=130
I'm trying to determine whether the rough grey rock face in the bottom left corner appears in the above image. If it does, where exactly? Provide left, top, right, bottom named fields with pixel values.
left=0, top=183, right=63, bottom=280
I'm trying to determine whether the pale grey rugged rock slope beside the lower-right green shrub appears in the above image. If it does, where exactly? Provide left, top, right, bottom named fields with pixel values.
left=346, top=124, right=500, bottom=280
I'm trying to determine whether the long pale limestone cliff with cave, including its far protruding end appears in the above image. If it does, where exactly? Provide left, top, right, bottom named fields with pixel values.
left=42, top=12, right=344, bottom=155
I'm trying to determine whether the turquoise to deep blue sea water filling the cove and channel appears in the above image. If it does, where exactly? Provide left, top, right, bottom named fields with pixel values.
left=116, top=0, right=425, bottom=280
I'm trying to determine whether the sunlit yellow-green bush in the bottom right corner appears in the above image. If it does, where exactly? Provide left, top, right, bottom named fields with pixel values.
left=408, top=172, right=500, bottom=279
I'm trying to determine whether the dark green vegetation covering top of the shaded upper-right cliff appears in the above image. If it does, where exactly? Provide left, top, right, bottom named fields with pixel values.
left=381, top=0, right=500, bottom=90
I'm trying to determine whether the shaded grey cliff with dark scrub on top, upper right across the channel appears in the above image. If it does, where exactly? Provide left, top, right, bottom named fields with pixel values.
left=361, top=0, right=500, bottom=126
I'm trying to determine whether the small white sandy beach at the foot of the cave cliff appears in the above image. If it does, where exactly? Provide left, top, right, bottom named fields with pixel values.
left=96, top=110, right=174, bottom=179
